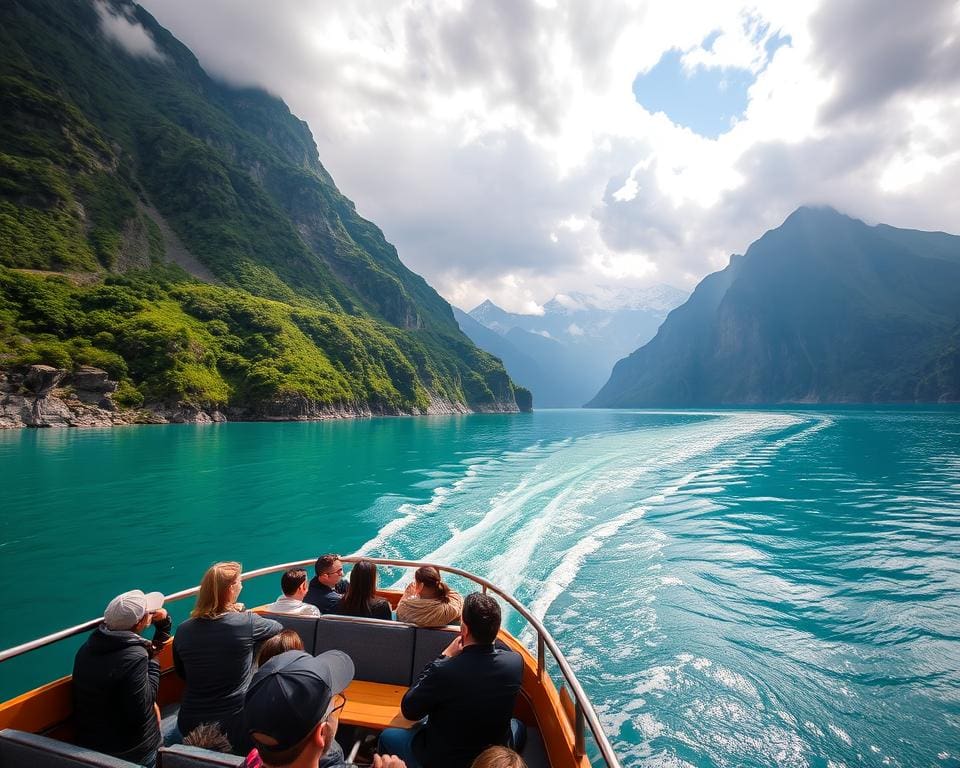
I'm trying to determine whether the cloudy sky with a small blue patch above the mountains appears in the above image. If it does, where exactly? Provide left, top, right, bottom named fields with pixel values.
left=126, top=0, right=960, bottom=313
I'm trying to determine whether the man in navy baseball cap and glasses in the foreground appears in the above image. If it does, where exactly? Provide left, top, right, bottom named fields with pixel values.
left=243, top=651, right=405, bottom=768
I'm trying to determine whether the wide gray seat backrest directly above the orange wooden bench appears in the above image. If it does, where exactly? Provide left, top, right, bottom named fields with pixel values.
left=313, top=615, right=415, bottom=685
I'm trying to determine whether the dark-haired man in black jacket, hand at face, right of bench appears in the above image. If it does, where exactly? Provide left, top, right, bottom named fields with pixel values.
left=380, top=592, right=526, bottom=768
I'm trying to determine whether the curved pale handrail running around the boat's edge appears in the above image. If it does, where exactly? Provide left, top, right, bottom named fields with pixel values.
left=0, top=555, right=621, bottom=768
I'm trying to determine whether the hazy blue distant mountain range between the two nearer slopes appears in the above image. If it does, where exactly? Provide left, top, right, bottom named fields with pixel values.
left=454, top=285, right=687, bottom=408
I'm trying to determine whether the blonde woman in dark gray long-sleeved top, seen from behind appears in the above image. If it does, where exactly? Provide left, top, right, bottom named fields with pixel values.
left=173, top=563, right=283, bottom=754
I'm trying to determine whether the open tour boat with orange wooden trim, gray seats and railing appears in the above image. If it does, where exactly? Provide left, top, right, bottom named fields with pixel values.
left=0, top=556, right=620, bottom=768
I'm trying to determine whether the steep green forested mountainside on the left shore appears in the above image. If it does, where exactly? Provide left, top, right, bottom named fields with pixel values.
left=0, top=0, right=529, bottom=418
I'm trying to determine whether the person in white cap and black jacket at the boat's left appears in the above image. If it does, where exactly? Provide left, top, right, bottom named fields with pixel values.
left=72, top=589, right=171, bottom=767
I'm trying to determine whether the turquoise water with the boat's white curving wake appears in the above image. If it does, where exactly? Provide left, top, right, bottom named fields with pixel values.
left=0, top=408, right=960, bottom=766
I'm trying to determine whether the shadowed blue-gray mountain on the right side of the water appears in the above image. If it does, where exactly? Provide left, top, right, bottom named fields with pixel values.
left=589, top=208, right=960, bottom=408
